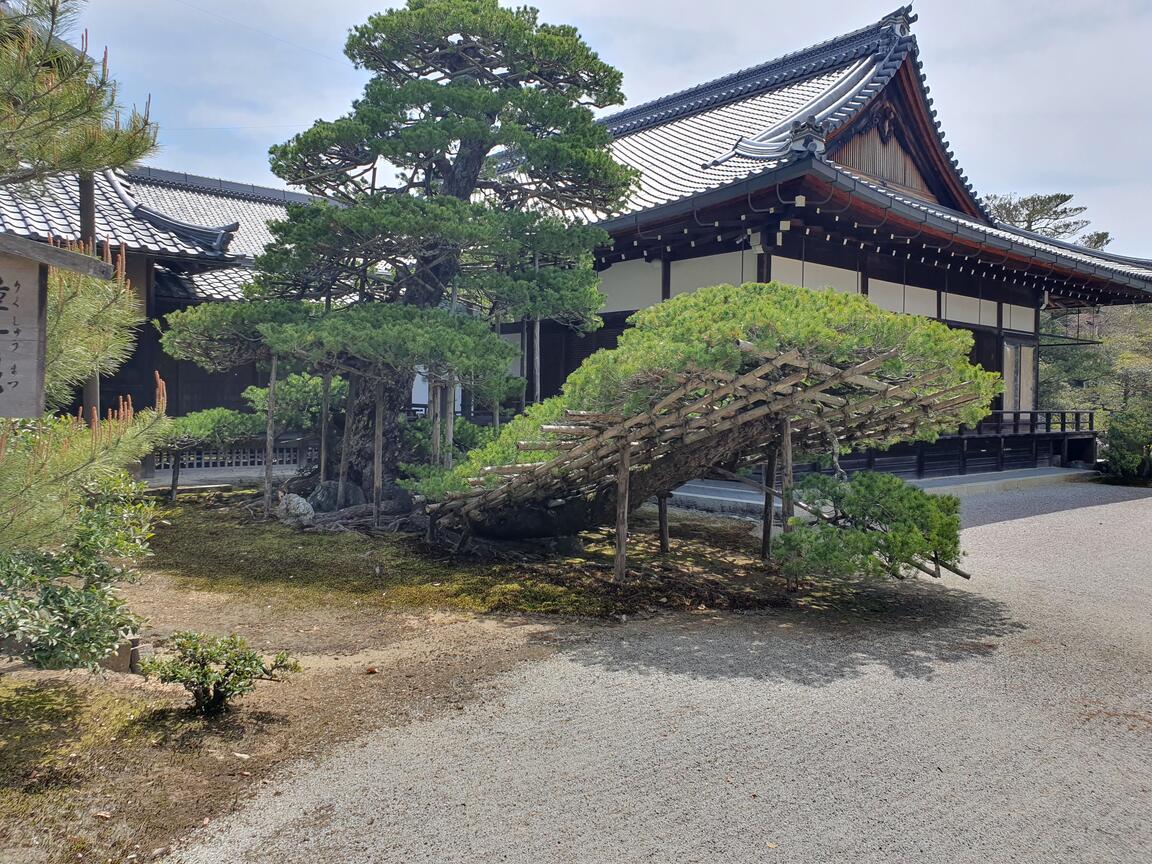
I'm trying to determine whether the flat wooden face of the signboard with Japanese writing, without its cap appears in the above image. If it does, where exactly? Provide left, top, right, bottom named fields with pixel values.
left=0, top=253, right=48, bottom=417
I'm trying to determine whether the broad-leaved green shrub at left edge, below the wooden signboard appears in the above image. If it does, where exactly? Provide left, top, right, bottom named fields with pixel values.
left=0, top=473, right=153, bottom=668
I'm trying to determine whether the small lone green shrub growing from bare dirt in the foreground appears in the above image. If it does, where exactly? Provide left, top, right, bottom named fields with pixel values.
left=143, top=631, right=300, bottom=714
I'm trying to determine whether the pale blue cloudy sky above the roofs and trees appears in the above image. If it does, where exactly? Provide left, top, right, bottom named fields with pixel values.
left=77, top=0, right=1152, bottom=258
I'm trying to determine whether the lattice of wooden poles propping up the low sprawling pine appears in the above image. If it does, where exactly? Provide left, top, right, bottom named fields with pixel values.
left=429, top=342, right=979, bottom=578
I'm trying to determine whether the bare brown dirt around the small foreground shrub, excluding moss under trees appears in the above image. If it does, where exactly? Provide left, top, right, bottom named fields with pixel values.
left=0, top=575, right=563, bottom=864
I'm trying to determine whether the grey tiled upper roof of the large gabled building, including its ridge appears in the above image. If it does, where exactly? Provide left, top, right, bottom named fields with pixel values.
left=601, top=6, right=982, bottom=221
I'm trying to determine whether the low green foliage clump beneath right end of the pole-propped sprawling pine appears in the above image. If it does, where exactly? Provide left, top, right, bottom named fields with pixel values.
left=775, top=471, right=962, bottom=584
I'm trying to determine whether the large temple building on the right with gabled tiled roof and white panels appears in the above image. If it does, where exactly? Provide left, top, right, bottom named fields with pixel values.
left=523, top=7, right=1152, bottom=476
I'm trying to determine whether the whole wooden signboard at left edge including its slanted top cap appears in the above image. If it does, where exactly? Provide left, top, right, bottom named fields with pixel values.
left=0, top=234, right=115, bottom=418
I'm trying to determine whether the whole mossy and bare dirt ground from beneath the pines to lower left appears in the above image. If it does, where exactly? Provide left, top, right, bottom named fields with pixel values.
left=0, top=499, right=820, bottom=864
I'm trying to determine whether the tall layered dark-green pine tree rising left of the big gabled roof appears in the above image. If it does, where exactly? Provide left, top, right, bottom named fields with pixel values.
left=224, top=0, right=634, bottom=488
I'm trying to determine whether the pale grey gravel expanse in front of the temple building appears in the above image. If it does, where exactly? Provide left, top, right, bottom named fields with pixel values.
left=170, top=484, right=1152, bottom=864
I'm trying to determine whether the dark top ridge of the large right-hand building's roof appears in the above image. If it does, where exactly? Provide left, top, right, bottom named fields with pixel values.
left=598, top=5, right=917, bottom=136
